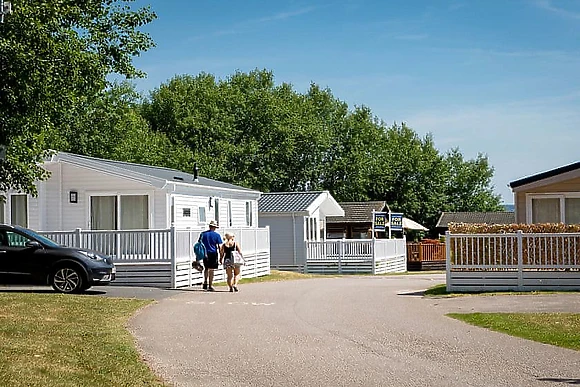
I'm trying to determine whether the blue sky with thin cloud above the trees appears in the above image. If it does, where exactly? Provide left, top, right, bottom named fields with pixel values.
left=129, top=0, right=580, bottom=203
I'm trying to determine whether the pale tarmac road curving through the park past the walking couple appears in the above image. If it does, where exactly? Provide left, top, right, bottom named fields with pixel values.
left=130, top=275, right=580, bottom=387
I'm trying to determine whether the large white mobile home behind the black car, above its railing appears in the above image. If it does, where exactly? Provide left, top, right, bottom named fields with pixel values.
left=0, top=152, right=260, bottom=231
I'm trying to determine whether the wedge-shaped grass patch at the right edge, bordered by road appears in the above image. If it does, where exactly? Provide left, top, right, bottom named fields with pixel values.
left=448, top=313, right=580, bottom=351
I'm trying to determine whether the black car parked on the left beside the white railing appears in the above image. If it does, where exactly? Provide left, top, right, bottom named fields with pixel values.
left=0, top=224, right=116, bottom=293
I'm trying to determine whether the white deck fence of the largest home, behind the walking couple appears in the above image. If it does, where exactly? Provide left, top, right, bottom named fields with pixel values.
left=40, top=227, right=270, bottom=288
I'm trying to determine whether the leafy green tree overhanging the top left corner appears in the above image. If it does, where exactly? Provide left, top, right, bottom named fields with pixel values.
left=0, top=0, right=155, bottom=197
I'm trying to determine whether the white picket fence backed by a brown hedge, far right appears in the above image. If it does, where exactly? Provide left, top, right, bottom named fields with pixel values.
left=445, top=231, right=580, bottom=292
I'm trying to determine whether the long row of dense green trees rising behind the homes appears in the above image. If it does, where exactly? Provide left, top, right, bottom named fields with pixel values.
left=142, top=70, right=500, bottom=232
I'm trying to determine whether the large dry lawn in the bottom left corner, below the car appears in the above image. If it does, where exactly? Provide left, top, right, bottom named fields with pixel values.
left=0, top=293, right=165, bottom=387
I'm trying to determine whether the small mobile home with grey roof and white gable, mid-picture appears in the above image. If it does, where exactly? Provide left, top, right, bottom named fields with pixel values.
left=258, top=191, right=344, bottom=270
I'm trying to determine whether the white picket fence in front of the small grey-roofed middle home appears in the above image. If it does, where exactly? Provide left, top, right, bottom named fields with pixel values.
left=304, top=239, right=407, bottom=274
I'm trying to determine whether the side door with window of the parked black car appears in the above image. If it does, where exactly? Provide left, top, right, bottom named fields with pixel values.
left=0, top=230, right=46, bottom=284
